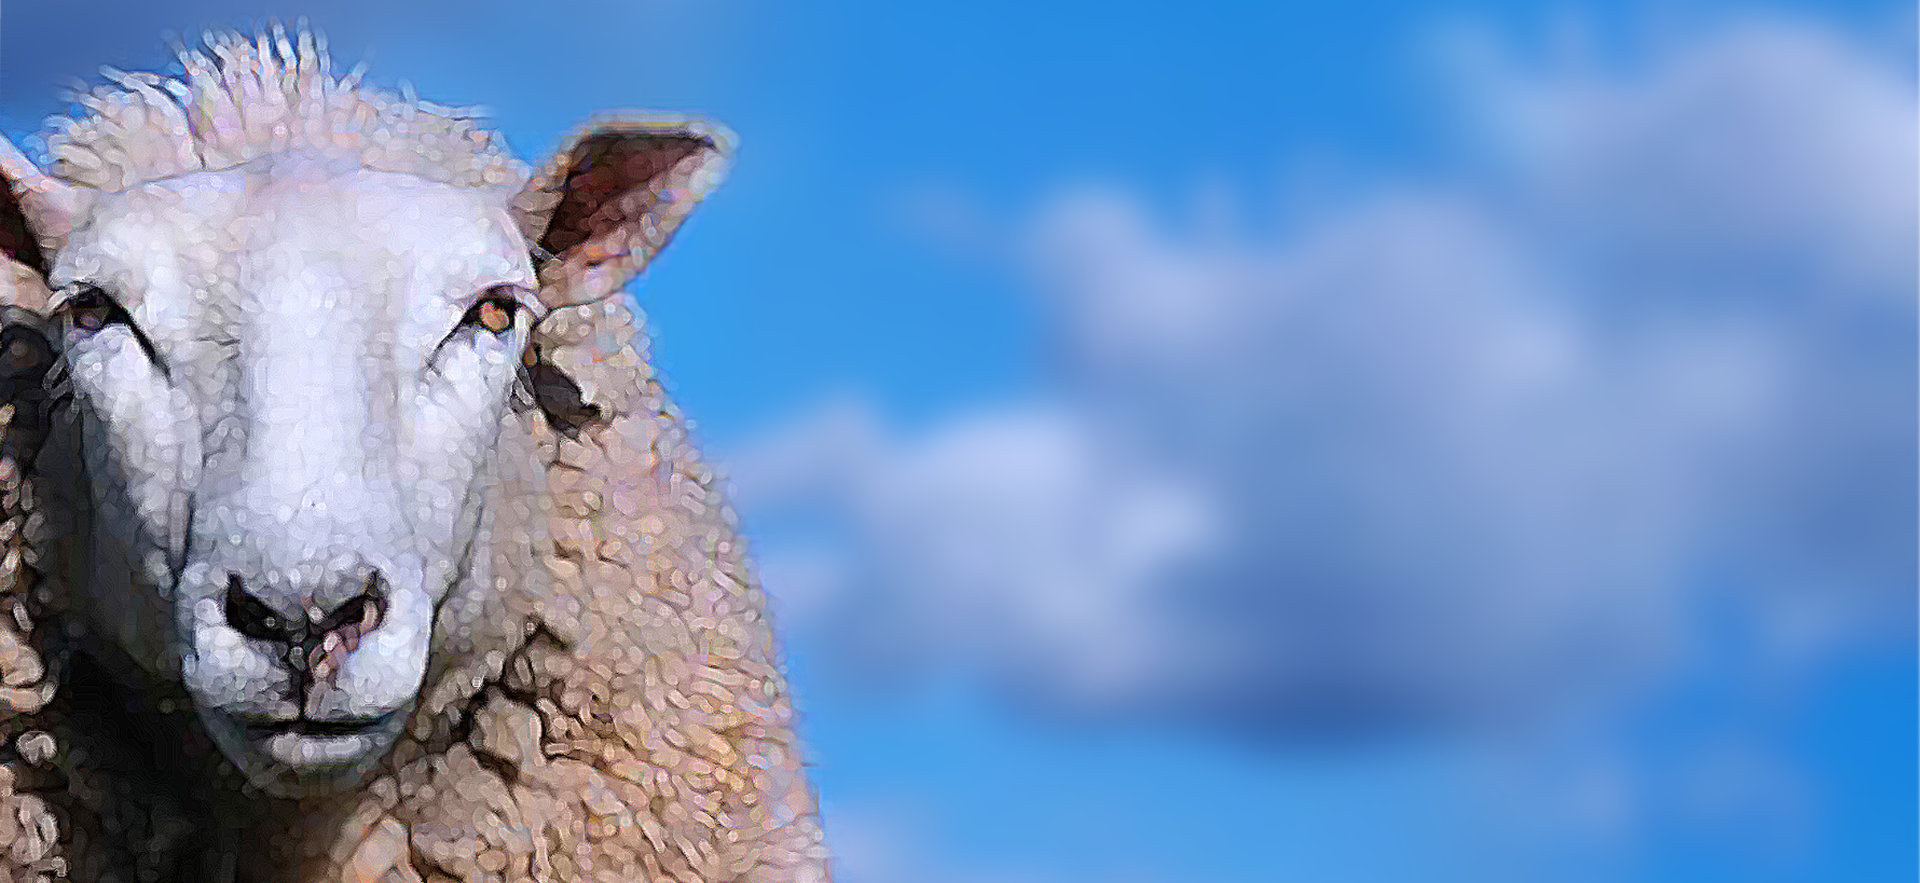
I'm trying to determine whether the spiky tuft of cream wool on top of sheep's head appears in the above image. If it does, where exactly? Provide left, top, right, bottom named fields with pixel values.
left=46, top=27, right=528, bottom=190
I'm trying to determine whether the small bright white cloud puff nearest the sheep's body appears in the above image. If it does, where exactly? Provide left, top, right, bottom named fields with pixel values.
left=733, top=405, right=1217, bottom=695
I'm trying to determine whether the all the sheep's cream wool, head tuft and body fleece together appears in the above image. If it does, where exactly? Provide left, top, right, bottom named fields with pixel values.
left=0, top=27, right=828, bottom=883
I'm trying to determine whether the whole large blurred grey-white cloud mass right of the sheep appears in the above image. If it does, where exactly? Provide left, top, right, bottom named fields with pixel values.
left=730, top=17, right=1920, bottom=737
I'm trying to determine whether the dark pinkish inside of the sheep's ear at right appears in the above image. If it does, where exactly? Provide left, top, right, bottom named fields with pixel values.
left=540, top=132, right=712, bottom=255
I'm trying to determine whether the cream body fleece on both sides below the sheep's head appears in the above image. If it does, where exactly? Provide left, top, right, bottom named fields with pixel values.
left=0, top=287, right=826, bottom=881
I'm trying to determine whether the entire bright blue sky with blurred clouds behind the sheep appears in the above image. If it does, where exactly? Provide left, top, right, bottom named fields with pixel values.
left=0, top=0, right=1920, bottom=883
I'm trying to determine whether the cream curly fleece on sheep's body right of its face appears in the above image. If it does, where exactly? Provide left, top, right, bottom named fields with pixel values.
left=353, top=301, right=824, bottom=881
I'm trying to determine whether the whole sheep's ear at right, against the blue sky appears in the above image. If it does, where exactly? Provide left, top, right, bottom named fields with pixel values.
left=513, top=119, right=733, bottom=307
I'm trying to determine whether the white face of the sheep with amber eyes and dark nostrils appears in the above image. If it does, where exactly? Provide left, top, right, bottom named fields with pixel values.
left=48, top=154, right=543, bottom=791
